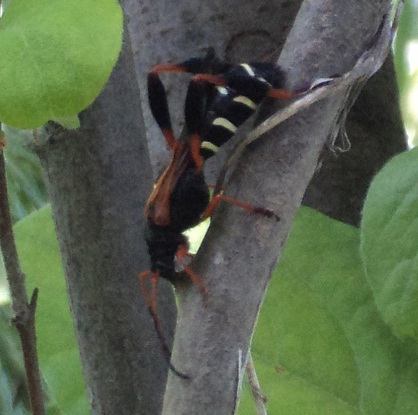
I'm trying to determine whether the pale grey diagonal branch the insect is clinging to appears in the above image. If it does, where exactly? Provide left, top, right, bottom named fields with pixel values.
left=163, top=1, right=396, bottom=415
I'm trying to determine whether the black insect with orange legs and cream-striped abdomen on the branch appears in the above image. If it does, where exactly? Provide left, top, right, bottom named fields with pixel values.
left=139, top=49, right=297, bottom=377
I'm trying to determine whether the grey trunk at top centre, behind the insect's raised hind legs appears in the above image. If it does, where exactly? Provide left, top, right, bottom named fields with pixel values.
left=125, top=0, right=301, bottom=179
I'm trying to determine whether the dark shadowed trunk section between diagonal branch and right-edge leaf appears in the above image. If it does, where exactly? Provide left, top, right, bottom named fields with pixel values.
left=303, top=55, right=406, bottom=226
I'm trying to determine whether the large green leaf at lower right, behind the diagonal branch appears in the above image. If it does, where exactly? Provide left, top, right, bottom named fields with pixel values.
left=240, top=208, right=418, bottom=415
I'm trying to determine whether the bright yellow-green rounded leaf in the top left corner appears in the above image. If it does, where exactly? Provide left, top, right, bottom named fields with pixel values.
left=0, top=0, right=123, bottom=128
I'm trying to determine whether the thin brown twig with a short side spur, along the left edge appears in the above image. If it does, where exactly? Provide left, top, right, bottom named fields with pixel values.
left=0, top=138, right=45, bottom=415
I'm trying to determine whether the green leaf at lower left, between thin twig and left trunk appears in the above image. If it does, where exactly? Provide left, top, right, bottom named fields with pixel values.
left=15, top=207, right=89, bottom=415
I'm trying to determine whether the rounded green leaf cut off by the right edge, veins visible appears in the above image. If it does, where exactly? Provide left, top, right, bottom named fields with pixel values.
left=361, top=148, right=418, bottom=340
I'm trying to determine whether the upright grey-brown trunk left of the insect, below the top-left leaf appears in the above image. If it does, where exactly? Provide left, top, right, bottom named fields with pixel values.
left=34, top=25, right=175, bottom=415
